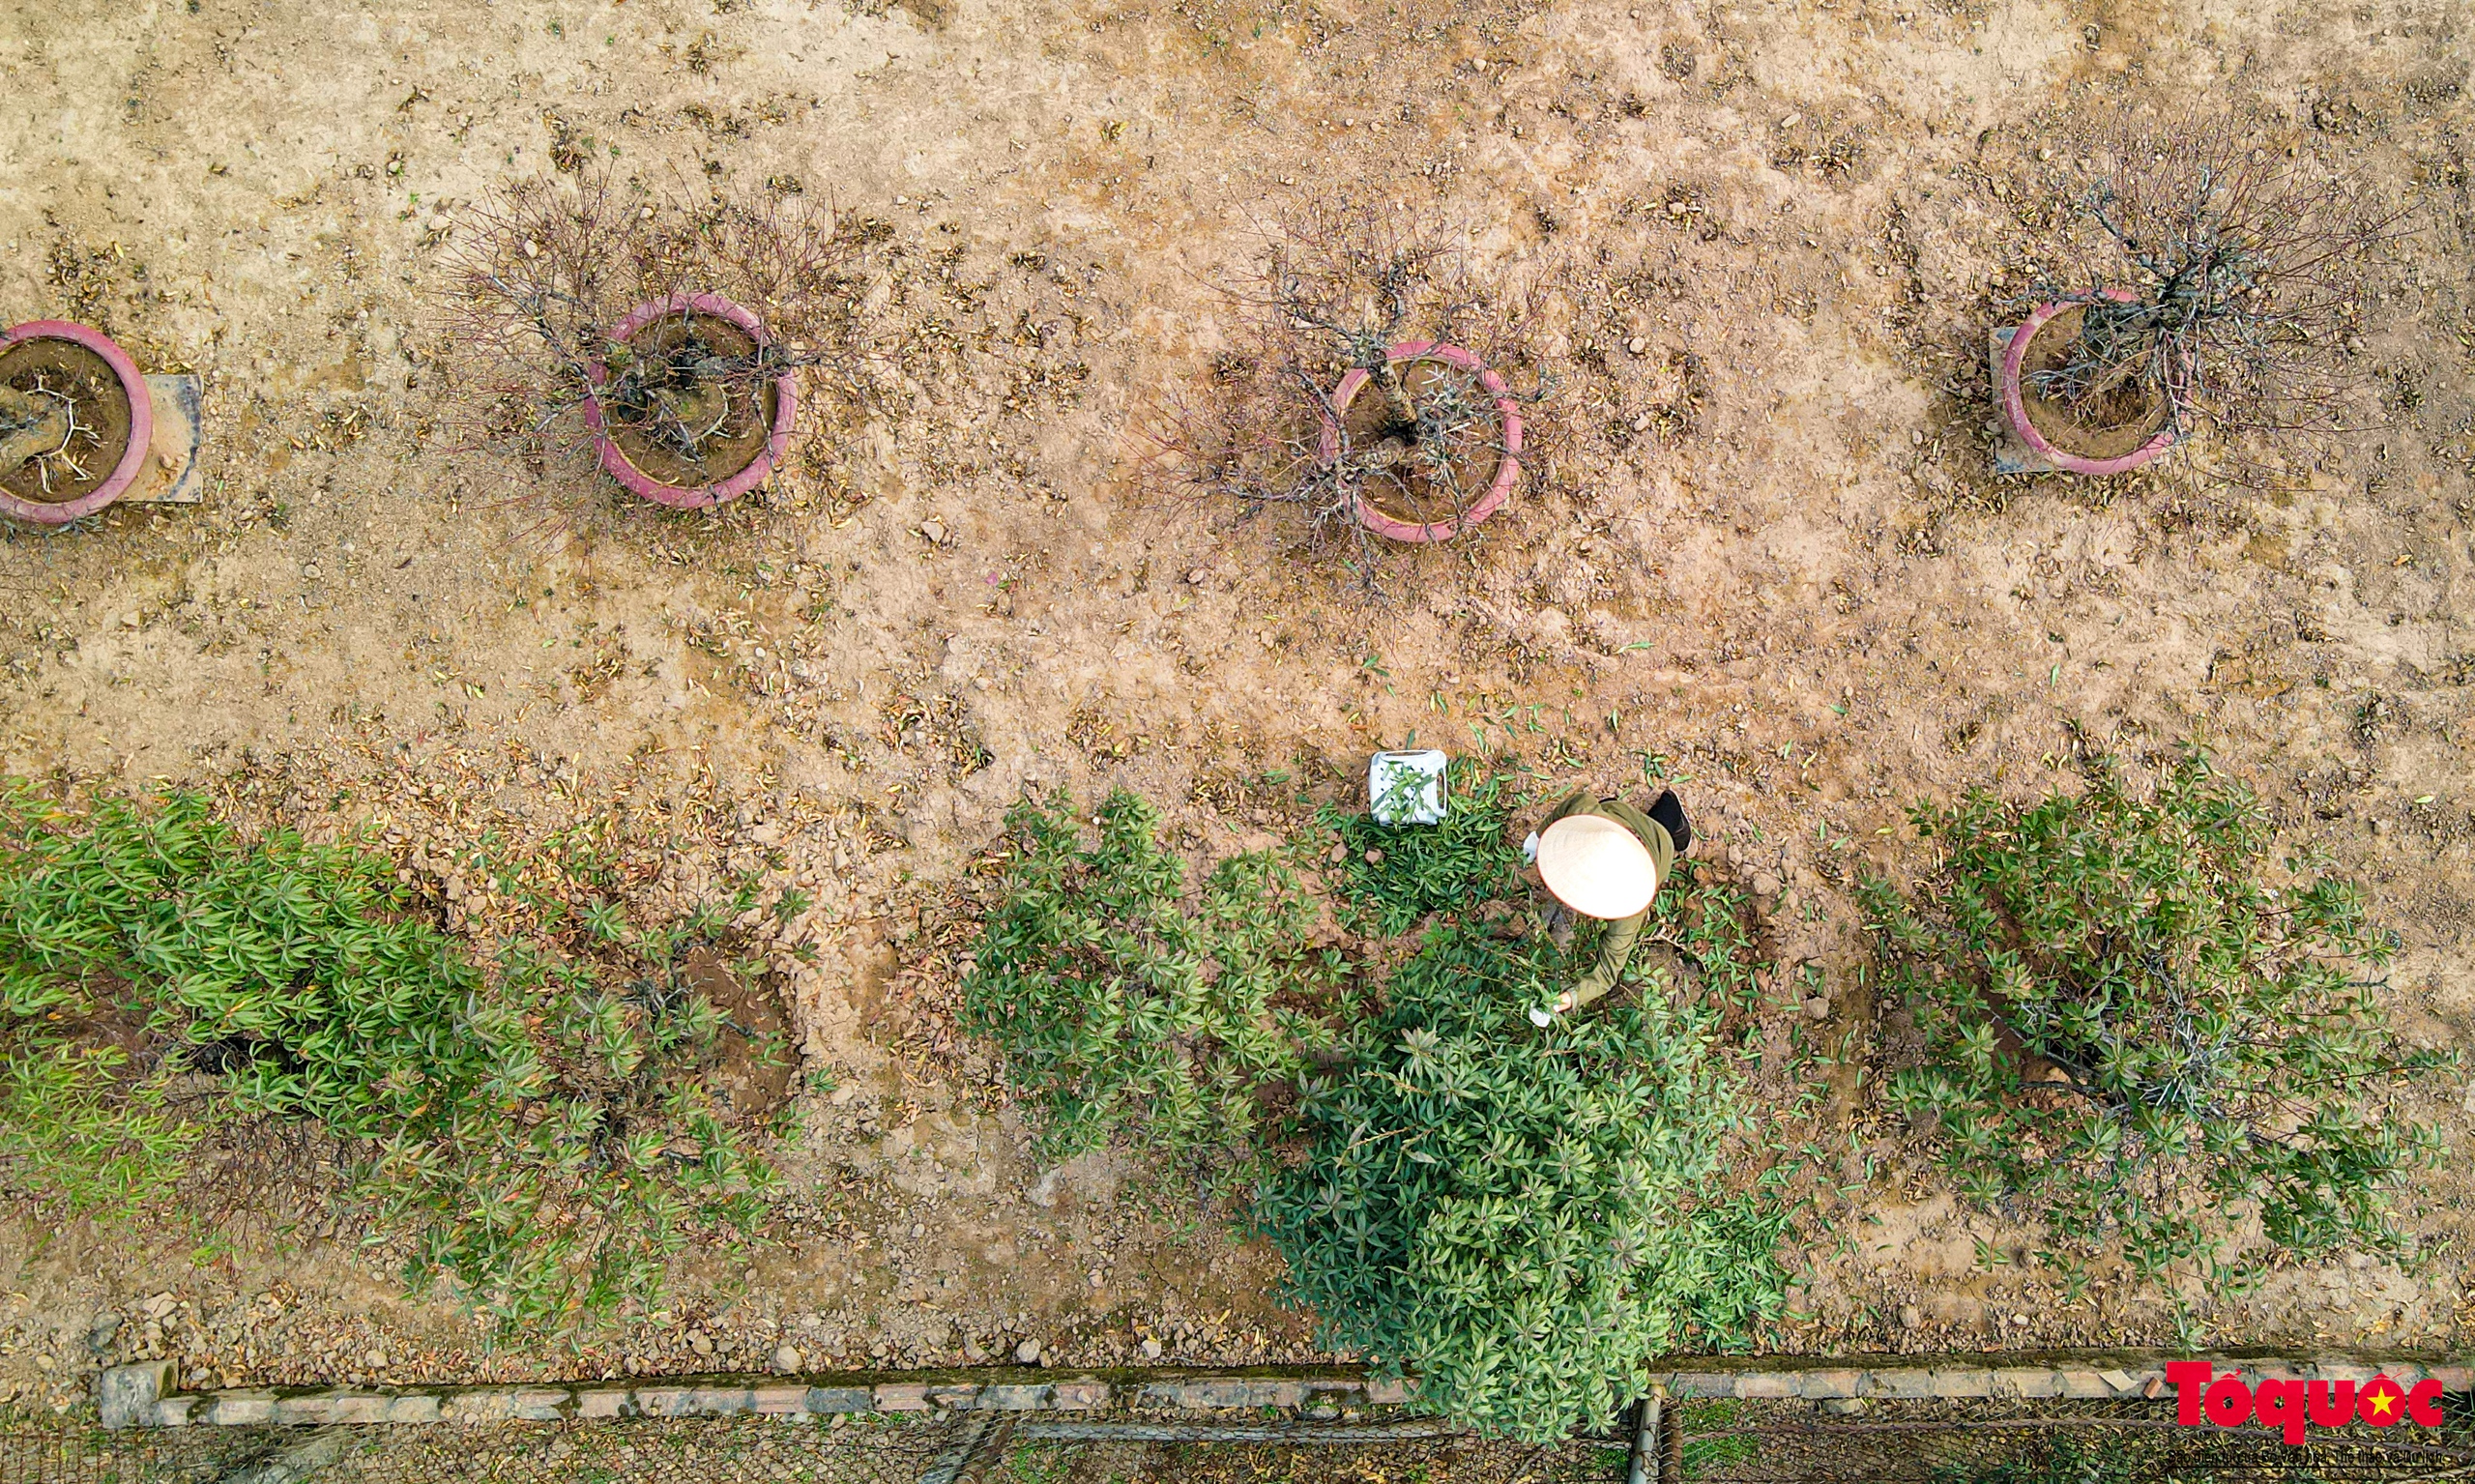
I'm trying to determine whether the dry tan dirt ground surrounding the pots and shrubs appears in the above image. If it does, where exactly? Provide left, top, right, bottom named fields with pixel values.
left=0, top=0, right=2475, bottom=1400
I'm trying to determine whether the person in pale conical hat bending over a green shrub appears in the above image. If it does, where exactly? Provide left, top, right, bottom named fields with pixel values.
left=1528, top=789, right=1693, bottom=1027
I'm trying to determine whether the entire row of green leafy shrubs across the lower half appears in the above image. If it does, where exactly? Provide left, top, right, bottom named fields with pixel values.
left=0, top=754, right=2450, bottom=1437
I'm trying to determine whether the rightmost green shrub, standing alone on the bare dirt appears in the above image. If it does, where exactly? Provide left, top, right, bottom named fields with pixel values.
left=1859, top=749, right=2453, bottom=1281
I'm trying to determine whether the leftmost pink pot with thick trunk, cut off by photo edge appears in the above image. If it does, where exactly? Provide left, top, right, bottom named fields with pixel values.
left=0, top=319, right=154, bottom=527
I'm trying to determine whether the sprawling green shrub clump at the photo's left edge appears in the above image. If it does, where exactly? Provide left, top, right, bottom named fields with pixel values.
left=0, top=787, right=772, bottom=1324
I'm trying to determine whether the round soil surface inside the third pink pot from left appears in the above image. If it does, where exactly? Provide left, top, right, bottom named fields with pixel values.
left=1342, top=359, right=1504, bottom=524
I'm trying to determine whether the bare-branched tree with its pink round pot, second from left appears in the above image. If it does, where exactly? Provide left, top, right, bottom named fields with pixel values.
left=441, top=176, right=859, bottom=509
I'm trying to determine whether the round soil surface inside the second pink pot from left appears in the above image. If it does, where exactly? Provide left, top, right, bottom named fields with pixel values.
left=599, top=311, right=779, bottom=490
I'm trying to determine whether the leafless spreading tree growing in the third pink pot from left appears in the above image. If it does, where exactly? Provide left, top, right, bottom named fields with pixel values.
left=1141, top=203, right=1539, bottom=581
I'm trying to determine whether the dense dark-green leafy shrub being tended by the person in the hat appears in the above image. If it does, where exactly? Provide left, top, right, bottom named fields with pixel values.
left=1257, top=922, right=1787, bottom=1440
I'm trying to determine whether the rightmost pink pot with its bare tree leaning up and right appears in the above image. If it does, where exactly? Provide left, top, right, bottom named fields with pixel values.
left=1997, top=114, right=2410, bottom=475
